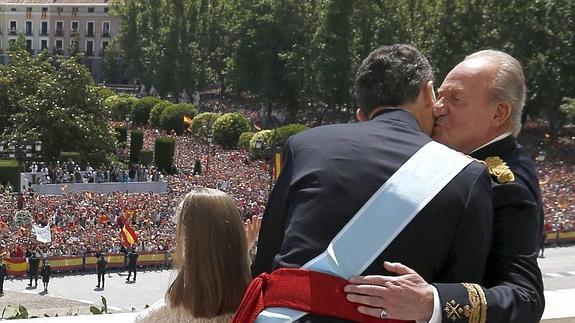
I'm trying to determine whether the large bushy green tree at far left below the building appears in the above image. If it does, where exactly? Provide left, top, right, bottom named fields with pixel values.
left=0, top=51, right=115, bottom=164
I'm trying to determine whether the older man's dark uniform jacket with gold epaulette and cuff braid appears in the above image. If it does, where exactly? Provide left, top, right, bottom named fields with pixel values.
left=435, top=136, right=545, bottom=323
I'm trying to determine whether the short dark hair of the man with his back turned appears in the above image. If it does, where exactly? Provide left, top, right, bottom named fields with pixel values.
left=354, top=44, right=433, bottom=115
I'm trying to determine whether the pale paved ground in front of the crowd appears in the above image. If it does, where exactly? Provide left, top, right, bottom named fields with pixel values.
left=0, top=246, right=575, bottom=323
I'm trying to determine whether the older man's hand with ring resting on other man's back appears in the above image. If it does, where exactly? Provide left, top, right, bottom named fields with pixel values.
left=344, top=261, right=433, bottom=321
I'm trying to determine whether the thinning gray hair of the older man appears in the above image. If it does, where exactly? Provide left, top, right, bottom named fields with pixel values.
left=465, top=49, right=526, bottom=137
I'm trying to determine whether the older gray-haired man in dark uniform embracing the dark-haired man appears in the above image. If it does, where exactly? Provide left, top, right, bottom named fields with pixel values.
left=345, top=50, right=545, bottom=323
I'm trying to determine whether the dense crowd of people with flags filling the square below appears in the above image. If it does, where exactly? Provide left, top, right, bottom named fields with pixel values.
left=0, top=93, right=575, bottom=266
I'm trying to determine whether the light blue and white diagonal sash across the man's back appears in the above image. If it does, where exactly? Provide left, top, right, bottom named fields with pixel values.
left=256, top=141, right=472, bottom=323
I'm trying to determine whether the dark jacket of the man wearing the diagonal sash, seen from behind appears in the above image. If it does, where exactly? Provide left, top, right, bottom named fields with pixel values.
left=252, top=109, right=492, bottom=322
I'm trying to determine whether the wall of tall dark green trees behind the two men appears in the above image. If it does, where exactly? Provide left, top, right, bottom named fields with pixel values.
left=110, top=0, right=575, bottom=135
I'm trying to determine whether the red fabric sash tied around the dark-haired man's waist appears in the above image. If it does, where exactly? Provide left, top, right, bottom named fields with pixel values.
left=232, top=268, right=411, bottom=323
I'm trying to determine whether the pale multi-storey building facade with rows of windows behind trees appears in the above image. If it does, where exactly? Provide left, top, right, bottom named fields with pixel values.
left=0, top=0, right=120, bottom=82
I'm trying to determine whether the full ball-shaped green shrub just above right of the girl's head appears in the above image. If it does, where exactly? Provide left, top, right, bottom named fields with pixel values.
left=213, top=112, right=250, bottom=148
